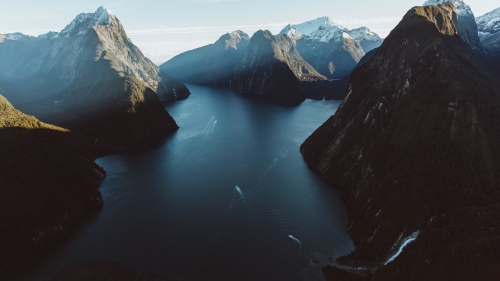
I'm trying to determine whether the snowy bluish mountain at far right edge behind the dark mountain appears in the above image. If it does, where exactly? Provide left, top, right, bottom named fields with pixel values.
left=476, top=8, right=500, bottom=57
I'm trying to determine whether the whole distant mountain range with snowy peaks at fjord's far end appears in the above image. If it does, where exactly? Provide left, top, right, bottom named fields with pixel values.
left=160, top=17, right=382, bottom=103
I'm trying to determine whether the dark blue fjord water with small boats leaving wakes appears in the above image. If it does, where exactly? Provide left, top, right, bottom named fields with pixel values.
left=5, top=85, right=354, bottom=280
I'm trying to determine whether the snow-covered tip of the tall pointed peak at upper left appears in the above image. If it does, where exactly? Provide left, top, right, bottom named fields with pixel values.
left=59, top=6, right=116, bottom=37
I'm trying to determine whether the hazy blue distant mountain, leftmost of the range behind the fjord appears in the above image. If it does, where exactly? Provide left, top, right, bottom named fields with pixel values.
left=160, top=30, right=250, bottom=87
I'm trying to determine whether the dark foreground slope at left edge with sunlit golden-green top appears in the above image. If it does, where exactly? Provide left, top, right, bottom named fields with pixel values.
left=0, top=95, right=105, bottom=273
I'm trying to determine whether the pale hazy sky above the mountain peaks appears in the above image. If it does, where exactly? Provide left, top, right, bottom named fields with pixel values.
left=0, top=0, right=500, bottom=64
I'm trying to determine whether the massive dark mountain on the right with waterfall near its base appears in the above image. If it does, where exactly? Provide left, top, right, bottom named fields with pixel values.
left=301, top=3, right=500, bottom=280
